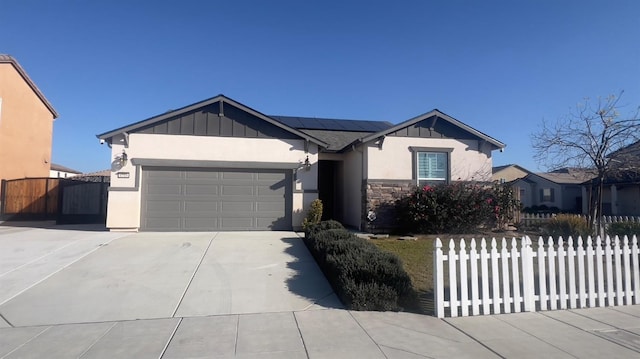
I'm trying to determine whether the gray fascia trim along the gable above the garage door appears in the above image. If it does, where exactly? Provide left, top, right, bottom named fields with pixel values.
left=96, top=94, right=328, bottom=147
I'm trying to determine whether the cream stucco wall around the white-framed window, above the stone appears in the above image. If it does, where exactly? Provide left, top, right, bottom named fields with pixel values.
left=366, top=137, right=492, bottom=181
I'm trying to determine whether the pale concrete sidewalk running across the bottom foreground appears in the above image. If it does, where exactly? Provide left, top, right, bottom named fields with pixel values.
left=0, top=306, right=640, bottom=358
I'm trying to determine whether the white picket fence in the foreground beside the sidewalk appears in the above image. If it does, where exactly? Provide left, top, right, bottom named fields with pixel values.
left=433, top=236, right=640, bottom=318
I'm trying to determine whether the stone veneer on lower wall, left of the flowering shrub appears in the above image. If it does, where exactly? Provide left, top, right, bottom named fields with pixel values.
left=362, top=180, right=416, bottom=233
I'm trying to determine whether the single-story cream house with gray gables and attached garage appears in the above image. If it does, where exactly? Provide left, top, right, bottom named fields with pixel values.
left=98, top=95, right=505, bottom=231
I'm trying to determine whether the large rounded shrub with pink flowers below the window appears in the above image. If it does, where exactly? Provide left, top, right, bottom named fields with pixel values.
left=397, top=182, right=518, bottom=233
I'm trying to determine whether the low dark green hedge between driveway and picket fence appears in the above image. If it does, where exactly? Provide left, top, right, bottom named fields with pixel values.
left=305, top=221, right=413, bottom=311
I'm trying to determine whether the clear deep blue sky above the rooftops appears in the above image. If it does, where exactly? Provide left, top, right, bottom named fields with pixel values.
left=0, top=0, right=640, bottom=172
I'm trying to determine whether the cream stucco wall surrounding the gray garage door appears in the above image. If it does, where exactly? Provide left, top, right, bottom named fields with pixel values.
left=107, top=134, right=318, bottom=229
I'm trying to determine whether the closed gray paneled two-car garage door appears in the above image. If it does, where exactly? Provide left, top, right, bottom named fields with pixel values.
left=141, top=168, right=291, bottom=231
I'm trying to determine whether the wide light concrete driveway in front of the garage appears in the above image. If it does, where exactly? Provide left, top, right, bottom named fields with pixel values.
left=0, top=227, right=341, bottom=327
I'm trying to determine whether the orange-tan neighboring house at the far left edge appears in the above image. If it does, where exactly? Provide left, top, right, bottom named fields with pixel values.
left=0, top=54, right=58, bottom=186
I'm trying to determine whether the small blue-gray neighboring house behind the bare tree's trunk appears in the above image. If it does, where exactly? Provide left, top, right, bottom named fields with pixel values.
left=511, top=169, right=593, bottom=213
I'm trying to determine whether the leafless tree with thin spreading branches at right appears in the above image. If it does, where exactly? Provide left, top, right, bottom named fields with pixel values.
left=531, top=92, right=640, bottom=233
